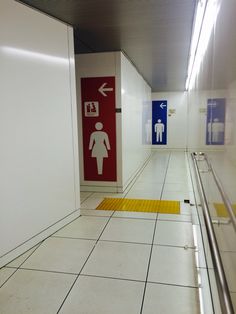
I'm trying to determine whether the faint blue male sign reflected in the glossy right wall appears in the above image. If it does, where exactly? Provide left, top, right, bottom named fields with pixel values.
left=206, top=98, right=225, bottom=145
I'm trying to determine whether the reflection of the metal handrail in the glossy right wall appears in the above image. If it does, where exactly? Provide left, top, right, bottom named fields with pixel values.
left=204, top=154, right=236, bottom=232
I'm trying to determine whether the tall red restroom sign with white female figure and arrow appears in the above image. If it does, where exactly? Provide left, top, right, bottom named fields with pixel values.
left=81, top=77, right=116, bottom=181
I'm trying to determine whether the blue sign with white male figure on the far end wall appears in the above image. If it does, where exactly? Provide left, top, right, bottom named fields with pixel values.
left=152, top=100, right=167, bottom=145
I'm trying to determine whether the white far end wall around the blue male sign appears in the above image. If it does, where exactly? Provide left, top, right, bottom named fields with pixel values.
left=152, top=92, right=188, bottom=149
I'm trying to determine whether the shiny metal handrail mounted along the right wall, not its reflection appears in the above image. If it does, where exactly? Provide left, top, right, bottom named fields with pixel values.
left=191, top=153, right=234, bottom=314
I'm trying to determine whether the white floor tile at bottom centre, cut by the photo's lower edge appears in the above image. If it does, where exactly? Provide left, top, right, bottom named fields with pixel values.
left=60, top=276, right=144, bottom=314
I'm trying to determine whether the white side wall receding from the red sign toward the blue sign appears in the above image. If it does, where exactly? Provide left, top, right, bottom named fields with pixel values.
left=121, top=54, right=151, bottom=187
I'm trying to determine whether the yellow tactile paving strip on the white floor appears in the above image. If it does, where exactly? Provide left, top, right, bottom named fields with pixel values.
left=96, top=198, right=180, bottom=214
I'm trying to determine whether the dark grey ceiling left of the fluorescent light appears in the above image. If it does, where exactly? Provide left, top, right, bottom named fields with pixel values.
left=18, top=0, right=196, bottom=92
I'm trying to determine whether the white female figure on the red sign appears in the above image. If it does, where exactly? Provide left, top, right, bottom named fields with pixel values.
left=89, top=122, right=111, bottom=175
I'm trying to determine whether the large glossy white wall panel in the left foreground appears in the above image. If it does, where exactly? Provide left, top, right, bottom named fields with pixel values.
left=0, top=0, right=80, bottom=265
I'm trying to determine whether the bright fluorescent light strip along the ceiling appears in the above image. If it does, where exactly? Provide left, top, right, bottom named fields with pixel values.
left=185, top=0, right=220, bottom=90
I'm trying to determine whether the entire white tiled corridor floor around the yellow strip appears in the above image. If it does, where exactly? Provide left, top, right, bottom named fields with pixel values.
left=0, top=152, right=200, bottom=314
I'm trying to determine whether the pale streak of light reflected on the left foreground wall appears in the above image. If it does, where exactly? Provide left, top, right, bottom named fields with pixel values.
left=1, top=46, right=69, bottom=64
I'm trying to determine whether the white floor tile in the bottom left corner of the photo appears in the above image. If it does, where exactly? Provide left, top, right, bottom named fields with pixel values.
left=0, top=269, right=76, bottom=314
